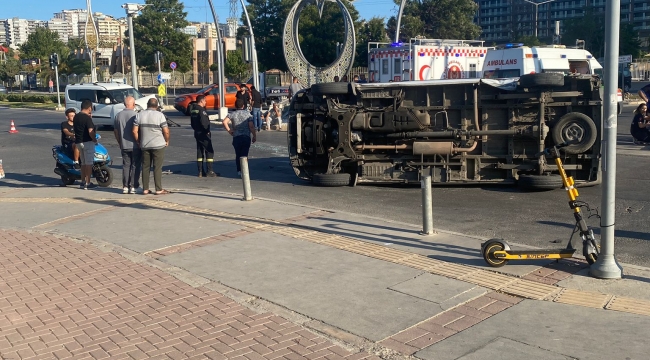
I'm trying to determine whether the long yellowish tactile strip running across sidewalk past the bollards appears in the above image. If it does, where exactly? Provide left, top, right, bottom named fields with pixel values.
left=5, top=197, right=650, bottom=316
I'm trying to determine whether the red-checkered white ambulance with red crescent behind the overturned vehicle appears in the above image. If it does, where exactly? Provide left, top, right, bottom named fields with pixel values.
left=368, top=38, right=492, bottom=83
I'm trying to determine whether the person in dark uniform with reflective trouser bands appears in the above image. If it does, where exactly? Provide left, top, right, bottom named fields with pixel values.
left=190, top=95, right=219, bottom=177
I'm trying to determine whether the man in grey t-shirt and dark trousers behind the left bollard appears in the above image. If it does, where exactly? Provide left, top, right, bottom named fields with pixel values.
left=223, top=99, right=257, bottom=176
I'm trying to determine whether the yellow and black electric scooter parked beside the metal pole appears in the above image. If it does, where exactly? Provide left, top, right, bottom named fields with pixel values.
left=481, top=142, right=600, bottom=267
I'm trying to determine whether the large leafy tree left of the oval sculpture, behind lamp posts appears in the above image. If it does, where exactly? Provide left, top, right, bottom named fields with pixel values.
left=129, top=0, right=192, bottom=71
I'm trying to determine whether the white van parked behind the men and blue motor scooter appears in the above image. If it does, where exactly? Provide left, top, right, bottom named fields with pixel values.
left=65, top=82, right=156, bottom=126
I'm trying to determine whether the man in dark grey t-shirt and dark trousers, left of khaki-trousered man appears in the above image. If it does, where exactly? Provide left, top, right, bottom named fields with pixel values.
left=113, top=96, right=142, bottom=194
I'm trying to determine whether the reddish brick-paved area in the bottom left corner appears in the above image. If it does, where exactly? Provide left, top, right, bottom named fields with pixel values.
left=0, top=229, right=378, bottom=360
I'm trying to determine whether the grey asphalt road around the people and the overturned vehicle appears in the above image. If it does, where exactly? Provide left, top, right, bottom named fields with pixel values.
left=0, top=106, right=650, bottom=266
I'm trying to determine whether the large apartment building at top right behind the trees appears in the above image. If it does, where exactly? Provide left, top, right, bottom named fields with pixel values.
left=474, top=0, right=650, bottom=43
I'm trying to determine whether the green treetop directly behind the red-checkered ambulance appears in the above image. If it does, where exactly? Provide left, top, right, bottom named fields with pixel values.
left=388, top=0, right=481, bottom=41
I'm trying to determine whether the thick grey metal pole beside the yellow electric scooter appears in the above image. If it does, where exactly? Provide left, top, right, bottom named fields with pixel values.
left=589, top=0, right=622, bottom=279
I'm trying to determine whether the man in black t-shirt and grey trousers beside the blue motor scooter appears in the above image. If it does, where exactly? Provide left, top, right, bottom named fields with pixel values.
left=72, top=99, right=97, bottom=190
